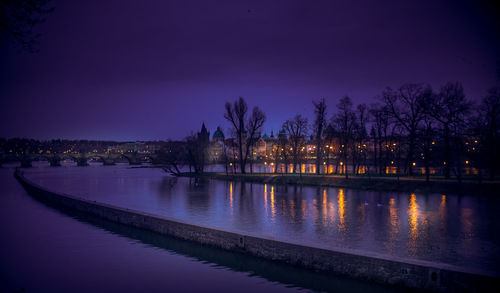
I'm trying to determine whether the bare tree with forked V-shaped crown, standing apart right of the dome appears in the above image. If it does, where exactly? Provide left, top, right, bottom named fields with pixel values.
left=224, top=97, right=266, bottom=174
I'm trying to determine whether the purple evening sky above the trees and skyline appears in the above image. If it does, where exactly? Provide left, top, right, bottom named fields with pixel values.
left=0, top=0, right=500, bottom=140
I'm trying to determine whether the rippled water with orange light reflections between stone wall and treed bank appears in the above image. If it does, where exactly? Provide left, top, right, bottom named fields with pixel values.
left=26, top=166, right=500, bottom=271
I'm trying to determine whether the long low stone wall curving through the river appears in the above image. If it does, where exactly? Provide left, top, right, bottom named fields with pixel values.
left=15, top=171, right=500, bottom=292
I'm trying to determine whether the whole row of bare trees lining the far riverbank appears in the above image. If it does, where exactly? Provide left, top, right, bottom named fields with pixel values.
left=158, top=82, right=500, bottom=181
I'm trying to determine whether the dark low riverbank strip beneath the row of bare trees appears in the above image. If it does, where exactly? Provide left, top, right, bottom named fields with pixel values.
left=181, top=172, right=500, bottom=196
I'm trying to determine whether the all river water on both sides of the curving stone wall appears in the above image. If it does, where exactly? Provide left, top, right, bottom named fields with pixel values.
left=0, top=165, right=500, bottom=291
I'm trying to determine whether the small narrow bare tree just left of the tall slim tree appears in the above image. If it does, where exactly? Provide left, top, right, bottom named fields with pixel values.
left=283, top=115, right=307, bottom=173
